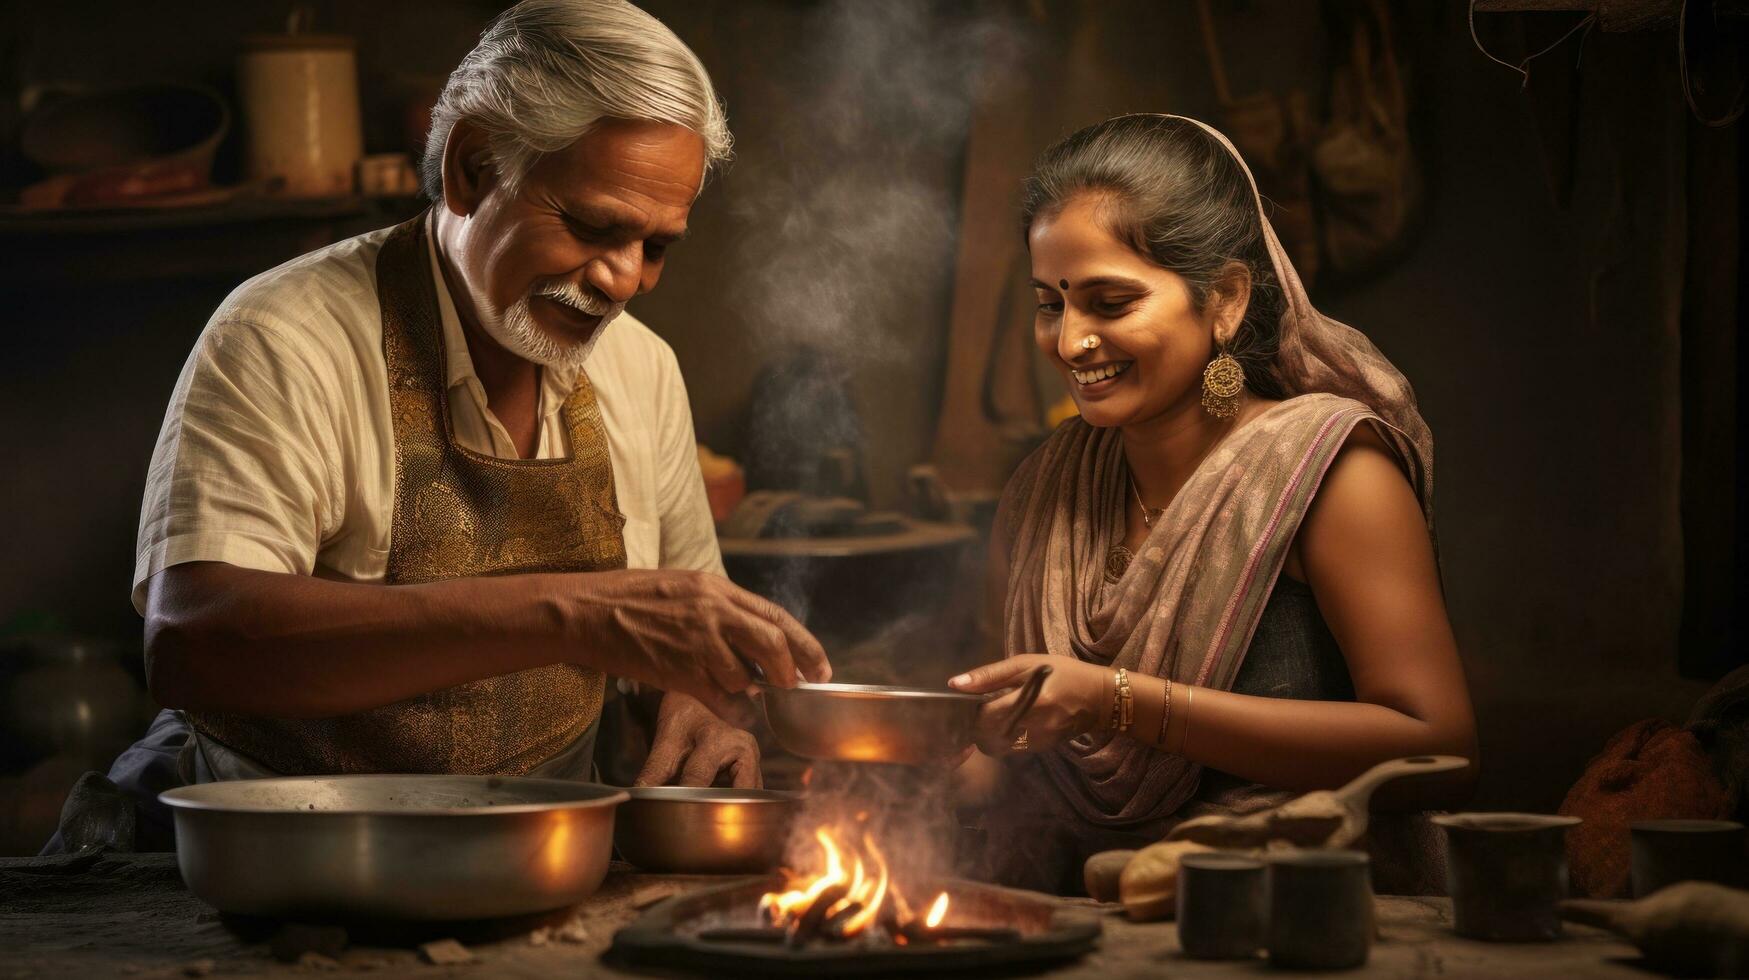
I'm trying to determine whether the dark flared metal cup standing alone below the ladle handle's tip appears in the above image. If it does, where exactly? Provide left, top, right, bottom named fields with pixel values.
left=1432, top=814, right=1579, bottom=942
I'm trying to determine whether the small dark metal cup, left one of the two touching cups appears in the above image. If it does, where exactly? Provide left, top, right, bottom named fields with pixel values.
left=1179, top=852, right=1268, bottom=959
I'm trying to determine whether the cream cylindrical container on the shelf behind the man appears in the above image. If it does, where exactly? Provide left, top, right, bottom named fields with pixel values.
left=236, top=33, right=364, bottom=198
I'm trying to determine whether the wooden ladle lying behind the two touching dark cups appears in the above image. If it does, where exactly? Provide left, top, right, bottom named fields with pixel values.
left=1167, top=756, right=1469, bottom=849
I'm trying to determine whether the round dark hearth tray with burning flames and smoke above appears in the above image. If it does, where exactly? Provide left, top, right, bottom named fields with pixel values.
left=612, top=763, right=1100, bottom=975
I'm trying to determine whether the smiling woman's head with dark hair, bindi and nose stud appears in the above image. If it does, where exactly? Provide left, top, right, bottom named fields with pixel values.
left=1023, top=117, right=1284, bottom=425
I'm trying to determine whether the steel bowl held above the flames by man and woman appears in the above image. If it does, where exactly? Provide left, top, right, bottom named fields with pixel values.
left=761, top=684, right=988, bottom=765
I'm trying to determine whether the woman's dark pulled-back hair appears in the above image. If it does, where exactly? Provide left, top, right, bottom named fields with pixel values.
left=1021, top=116, right=1286, bottom=399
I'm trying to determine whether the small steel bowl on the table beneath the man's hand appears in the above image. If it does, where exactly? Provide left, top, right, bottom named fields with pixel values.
left=614, top=786, right=801, bottom=875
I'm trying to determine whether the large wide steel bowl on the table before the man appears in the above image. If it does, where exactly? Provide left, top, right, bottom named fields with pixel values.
left=159, top=775, right=626, bottom=921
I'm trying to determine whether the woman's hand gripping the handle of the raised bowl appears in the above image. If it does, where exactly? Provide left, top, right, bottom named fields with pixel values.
left=948, top=653, right=1112, bottom=756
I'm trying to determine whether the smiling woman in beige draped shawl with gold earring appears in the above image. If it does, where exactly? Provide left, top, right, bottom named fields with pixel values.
left=953, top=116, right=1476, bottom=891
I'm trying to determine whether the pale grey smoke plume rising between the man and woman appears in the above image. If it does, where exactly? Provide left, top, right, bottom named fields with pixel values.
left=724, top=0, right=1027, bottom=621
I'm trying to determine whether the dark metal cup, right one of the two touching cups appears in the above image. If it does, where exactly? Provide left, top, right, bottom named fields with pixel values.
left=1268, top=851, right=1373, bottom=970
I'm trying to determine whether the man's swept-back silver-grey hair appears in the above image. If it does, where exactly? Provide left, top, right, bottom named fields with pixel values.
left=420, top=0, right=733, bottom=201
